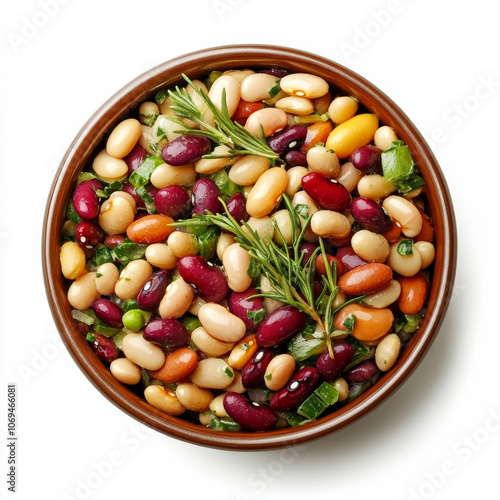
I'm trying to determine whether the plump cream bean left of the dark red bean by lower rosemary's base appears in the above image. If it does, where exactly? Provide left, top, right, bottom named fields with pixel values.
left=198, top=302, right=246, bottom=342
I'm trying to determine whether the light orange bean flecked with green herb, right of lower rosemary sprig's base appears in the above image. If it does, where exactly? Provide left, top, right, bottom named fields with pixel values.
left=334, top=304, right=394, bottom=341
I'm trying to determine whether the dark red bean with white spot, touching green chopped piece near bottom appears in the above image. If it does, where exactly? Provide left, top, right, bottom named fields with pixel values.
left=269, top=366, right=320, bottom=411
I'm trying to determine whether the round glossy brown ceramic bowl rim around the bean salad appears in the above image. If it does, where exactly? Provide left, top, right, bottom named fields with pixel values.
left=42, top=45, right=456, bottom=450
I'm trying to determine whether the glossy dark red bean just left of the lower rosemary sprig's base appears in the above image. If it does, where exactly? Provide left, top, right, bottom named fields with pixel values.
left=255, top=306, right=307, bottom=347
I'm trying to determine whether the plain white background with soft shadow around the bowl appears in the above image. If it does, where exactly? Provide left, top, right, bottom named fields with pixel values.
left=0, top=0, right=500, bottom=500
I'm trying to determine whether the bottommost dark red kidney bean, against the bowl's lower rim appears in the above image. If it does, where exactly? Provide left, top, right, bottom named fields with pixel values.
left=223, top=392, right=278, bottom=431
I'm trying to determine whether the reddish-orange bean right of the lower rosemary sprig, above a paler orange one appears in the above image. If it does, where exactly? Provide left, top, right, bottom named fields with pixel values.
left=338, top=262, right=392, bottom=295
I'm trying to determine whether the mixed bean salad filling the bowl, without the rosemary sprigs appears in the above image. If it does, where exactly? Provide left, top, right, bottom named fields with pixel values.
left=60, top=68, right=435, bottom=431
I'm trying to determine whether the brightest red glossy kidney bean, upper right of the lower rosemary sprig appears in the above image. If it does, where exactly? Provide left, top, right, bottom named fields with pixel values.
left=302, top=172, right=351, bottom=212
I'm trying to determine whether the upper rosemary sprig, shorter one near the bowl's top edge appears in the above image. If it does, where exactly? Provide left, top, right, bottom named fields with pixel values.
left=168, top=74, right=281, bottom=165
